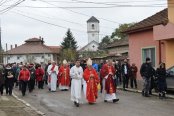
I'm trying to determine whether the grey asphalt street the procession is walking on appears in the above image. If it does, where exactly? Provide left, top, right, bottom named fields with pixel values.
left=15, top=86, right=174, bottom=116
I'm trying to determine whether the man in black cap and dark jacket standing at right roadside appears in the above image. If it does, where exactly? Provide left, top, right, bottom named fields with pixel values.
left=140, top=58, right=155, bottom=97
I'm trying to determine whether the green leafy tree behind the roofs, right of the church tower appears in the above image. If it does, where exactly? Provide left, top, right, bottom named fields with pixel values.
left=111, top=23, right=135, bottom=39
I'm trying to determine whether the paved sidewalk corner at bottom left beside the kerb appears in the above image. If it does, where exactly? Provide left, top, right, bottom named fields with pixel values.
left=0, top=95, right=42, bottom=116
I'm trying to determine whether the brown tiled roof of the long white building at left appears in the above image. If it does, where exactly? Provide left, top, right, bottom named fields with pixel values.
left=7, top=38, right=60, bottom=55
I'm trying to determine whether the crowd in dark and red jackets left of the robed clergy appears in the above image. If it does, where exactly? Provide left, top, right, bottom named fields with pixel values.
left=0, top=63, right=47, bottom=96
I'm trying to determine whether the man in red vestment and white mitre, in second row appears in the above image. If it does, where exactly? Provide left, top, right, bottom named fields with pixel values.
left=58, top=60, right=70, bottom=91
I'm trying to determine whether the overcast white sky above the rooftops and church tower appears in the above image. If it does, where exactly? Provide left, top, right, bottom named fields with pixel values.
left=0, top=0, right=167, bottom=49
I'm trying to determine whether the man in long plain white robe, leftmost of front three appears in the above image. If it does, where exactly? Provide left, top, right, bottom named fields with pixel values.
left=70, top=60, right=83, bottom=107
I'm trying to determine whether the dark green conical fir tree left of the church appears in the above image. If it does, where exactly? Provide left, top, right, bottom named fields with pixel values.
left=61, top=29, right=77, bottom=50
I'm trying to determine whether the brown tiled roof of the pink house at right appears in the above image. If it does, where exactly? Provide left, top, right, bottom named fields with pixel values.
left=124, top=8, right=168, bottom=33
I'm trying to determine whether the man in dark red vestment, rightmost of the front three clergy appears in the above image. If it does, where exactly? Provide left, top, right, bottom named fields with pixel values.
left=100, top=60, right=119, bottom=103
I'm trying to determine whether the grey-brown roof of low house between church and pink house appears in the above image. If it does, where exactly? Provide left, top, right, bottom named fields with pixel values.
left=105, top=38, right=129, bottom=48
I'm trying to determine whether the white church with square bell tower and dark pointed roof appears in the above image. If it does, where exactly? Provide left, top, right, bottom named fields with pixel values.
left=79, top=16, right=100, bottom=52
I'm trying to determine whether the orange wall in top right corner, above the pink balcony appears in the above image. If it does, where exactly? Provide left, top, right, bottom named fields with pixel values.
left=167, top=0, right=174, bottom=23
